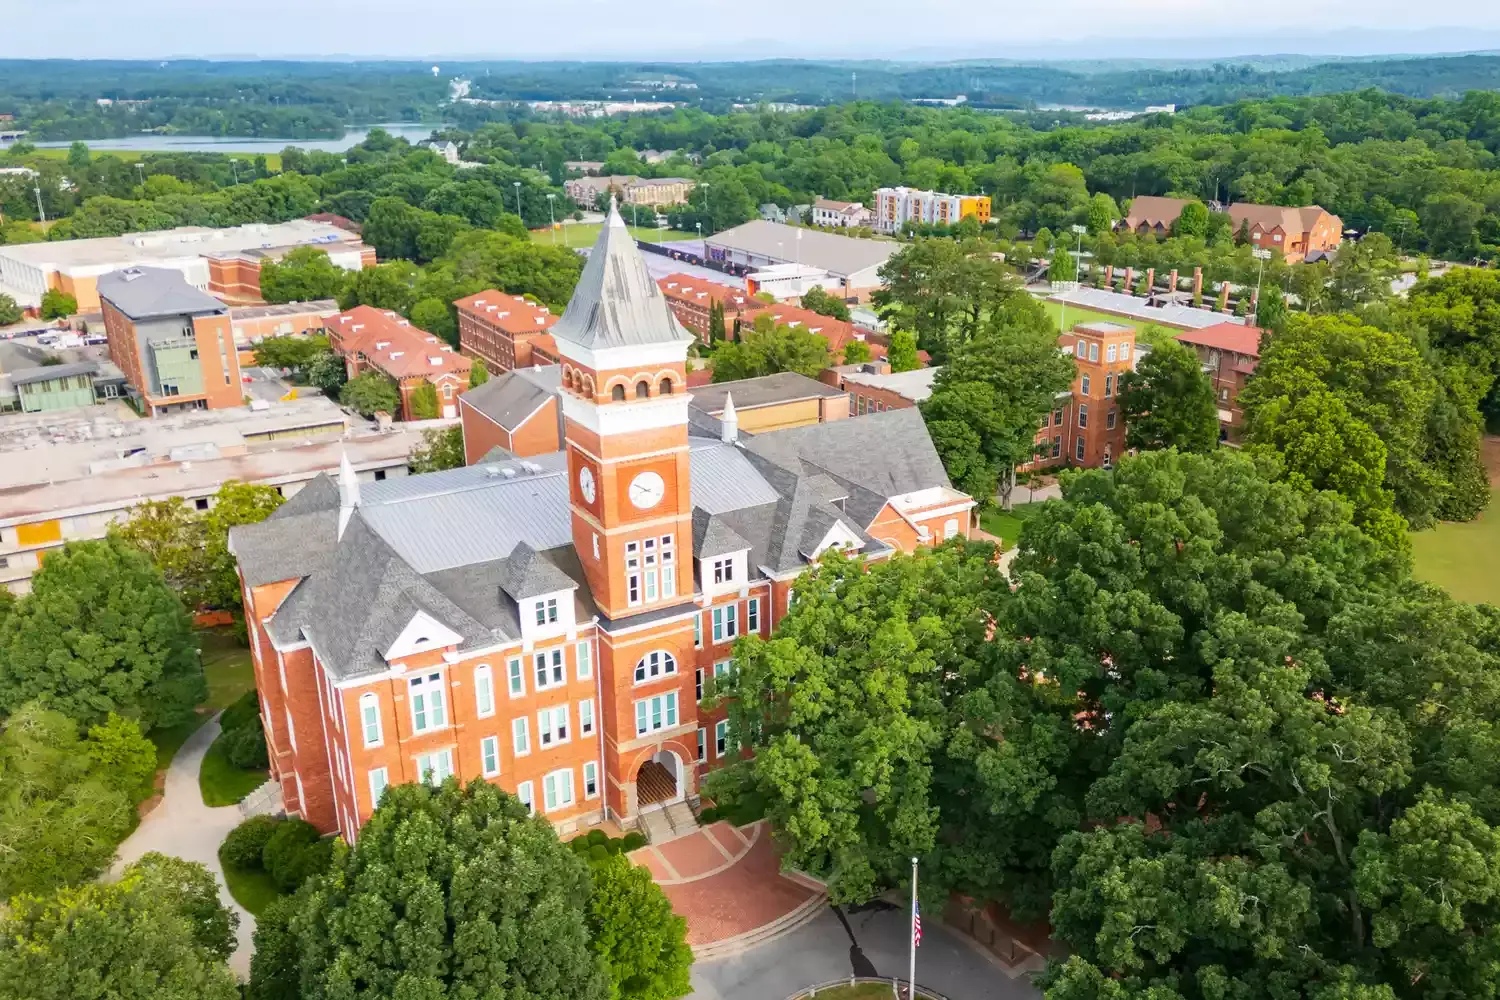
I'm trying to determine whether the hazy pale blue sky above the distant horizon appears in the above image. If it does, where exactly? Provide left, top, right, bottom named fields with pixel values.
left=17, top=0, right=1500, bottom=61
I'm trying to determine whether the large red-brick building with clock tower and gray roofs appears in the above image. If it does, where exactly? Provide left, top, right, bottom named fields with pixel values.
left=230, top=211, right=974, bottom=840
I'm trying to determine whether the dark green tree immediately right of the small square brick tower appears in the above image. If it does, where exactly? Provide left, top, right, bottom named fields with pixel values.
left=1119, top=340, right=1220, bottom=451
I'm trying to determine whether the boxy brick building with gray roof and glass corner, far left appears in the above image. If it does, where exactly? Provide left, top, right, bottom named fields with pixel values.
left=98, top=267, right=245, bottom=417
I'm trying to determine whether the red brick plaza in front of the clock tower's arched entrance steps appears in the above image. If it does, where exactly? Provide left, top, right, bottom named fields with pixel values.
left=630, top=820, right=819, bottom=948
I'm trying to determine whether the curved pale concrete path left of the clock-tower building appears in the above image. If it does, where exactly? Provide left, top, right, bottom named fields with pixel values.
left=111, top=715, right=255, bottom=979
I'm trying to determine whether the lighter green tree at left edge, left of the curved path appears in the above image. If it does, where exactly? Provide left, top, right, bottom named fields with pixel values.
left=0, top=703, right=156, bottom=898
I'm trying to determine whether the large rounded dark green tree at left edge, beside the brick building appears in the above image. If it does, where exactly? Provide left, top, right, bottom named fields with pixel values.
left=0, top=538, right=206, bottom=729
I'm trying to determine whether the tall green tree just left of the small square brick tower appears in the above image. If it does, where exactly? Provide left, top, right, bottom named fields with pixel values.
left=923, top=320, right=1074, bottom=510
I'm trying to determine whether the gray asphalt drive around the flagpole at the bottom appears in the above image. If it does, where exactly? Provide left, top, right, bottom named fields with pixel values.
left=690, top=903, right=1041, bottom=1000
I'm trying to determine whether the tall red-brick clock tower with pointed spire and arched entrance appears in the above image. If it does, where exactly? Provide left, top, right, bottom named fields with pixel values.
left=552, top=205, right=698, bottom=817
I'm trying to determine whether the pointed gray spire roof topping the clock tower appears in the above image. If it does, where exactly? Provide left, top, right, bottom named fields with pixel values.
left=551, top=202, right=693, bottom=351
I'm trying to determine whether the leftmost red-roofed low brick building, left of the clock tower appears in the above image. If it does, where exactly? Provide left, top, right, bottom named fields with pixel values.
left=327, top=306, right=473, bottom=420
